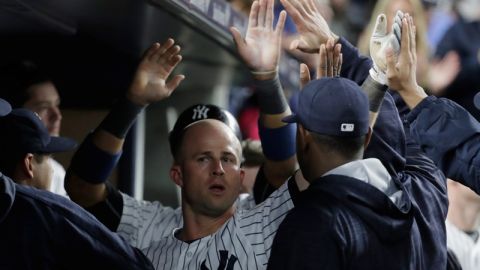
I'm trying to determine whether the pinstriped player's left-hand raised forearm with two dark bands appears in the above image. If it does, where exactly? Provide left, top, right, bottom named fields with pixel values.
left=65, top=98, right=143, bottom=207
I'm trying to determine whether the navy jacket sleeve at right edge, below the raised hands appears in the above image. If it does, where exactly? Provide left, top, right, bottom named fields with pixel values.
left=408, top=96, right=480, bottom=193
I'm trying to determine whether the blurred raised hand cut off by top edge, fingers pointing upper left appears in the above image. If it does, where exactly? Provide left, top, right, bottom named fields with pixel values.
left=280, top=0, right=338, bottom=53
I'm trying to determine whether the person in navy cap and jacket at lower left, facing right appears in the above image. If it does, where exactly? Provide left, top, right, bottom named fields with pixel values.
left=0, top=99, right=153, bottom=269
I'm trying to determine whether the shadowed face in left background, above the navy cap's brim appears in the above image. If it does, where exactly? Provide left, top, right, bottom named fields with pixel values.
left=23, top=82, right=62, bottom=136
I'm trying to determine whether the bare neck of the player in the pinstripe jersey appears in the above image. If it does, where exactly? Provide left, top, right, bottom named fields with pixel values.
left=177, top=206, right=235, bottom=242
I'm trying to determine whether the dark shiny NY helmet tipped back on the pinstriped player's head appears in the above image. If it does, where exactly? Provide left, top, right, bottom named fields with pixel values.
left=168, top=104, right=242, bottom=155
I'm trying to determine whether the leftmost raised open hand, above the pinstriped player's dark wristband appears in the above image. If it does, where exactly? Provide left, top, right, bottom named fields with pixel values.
left=127, top=38, right=185, bottom=106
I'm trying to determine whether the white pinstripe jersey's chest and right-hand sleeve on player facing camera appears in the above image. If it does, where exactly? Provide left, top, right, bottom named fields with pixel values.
left=143, top=182, right=293, bottom=270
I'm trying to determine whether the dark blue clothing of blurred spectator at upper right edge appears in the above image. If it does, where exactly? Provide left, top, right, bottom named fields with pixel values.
left=435, top=19, right=480, bottom=120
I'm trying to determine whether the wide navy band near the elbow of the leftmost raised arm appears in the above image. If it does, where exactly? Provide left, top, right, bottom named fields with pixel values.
left=70, top=134, right=122, bottom=184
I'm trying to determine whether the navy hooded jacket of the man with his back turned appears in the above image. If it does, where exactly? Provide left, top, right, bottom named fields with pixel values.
left=268, top=139, right=448, bottom=270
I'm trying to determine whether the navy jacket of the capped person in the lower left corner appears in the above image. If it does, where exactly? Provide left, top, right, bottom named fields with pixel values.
left=0, top=174, right=153, bottom=269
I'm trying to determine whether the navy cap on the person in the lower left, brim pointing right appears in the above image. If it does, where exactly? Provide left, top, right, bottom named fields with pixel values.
left=0, top=109, right=77, bottom=154
